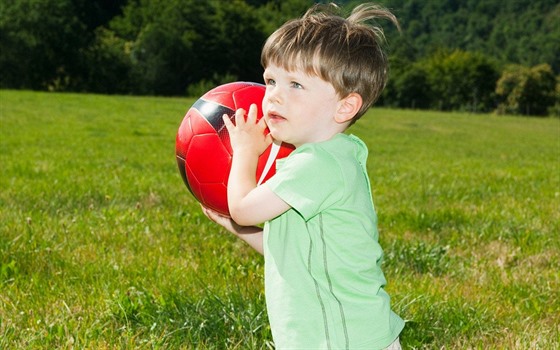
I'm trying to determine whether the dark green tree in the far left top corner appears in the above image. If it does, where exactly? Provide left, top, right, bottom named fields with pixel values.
left=0, top=0, right=91, bottom=90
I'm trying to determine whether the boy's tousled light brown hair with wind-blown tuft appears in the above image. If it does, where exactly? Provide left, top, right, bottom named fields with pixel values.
left=261, top=4, right=398, bottom=123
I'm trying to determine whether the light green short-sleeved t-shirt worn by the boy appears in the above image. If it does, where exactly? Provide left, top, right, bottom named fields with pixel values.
left=264, top=134, right=404, bottom=349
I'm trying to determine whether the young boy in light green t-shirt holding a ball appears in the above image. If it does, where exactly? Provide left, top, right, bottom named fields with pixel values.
left=204, top=4, right=404, bottom=349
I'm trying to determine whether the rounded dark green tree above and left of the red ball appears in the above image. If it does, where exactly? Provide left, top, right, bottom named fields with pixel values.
left=112, top=1, right=217, bottom=95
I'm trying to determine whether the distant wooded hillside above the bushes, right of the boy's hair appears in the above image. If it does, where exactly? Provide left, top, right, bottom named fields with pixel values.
left=382, top=0, right=560, bottom=72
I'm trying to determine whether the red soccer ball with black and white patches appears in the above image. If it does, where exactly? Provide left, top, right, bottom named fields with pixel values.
left=175, top=82, right=294, bottom=216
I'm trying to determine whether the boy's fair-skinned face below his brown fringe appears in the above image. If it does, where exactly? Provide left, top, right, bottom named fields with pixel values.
left=262, top=64, right=340, bottom=147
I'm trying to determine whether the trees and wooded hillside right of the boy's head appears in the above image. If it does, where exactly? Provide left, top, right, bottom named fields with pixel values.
left=376, top=0, right=560, bottom=116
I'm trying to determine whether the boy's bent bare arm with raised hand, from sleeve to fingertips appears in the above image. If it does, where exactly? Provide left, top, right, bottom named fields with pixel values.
left=223, top=105, right=290, bottom=226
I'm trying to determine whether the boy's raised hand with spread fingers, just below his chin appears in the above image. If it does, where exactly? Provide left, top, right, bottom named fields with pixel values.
left=223, top=104, right=272, bottom=157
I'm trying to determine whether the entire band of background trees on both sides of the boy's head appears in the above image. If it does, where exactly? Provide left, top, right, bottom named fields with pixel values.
left=0, top=0, right=560, bottom=115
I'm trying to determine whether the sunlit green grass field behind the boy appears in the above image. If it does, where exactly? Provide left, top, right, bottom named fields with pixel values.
left=0, top=91, right=560, bottom=349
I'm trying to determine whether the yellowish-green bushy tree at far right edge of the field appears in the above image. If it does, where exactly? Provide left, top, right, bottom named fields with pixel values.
left=496, top=64, right=558, bottom=115
